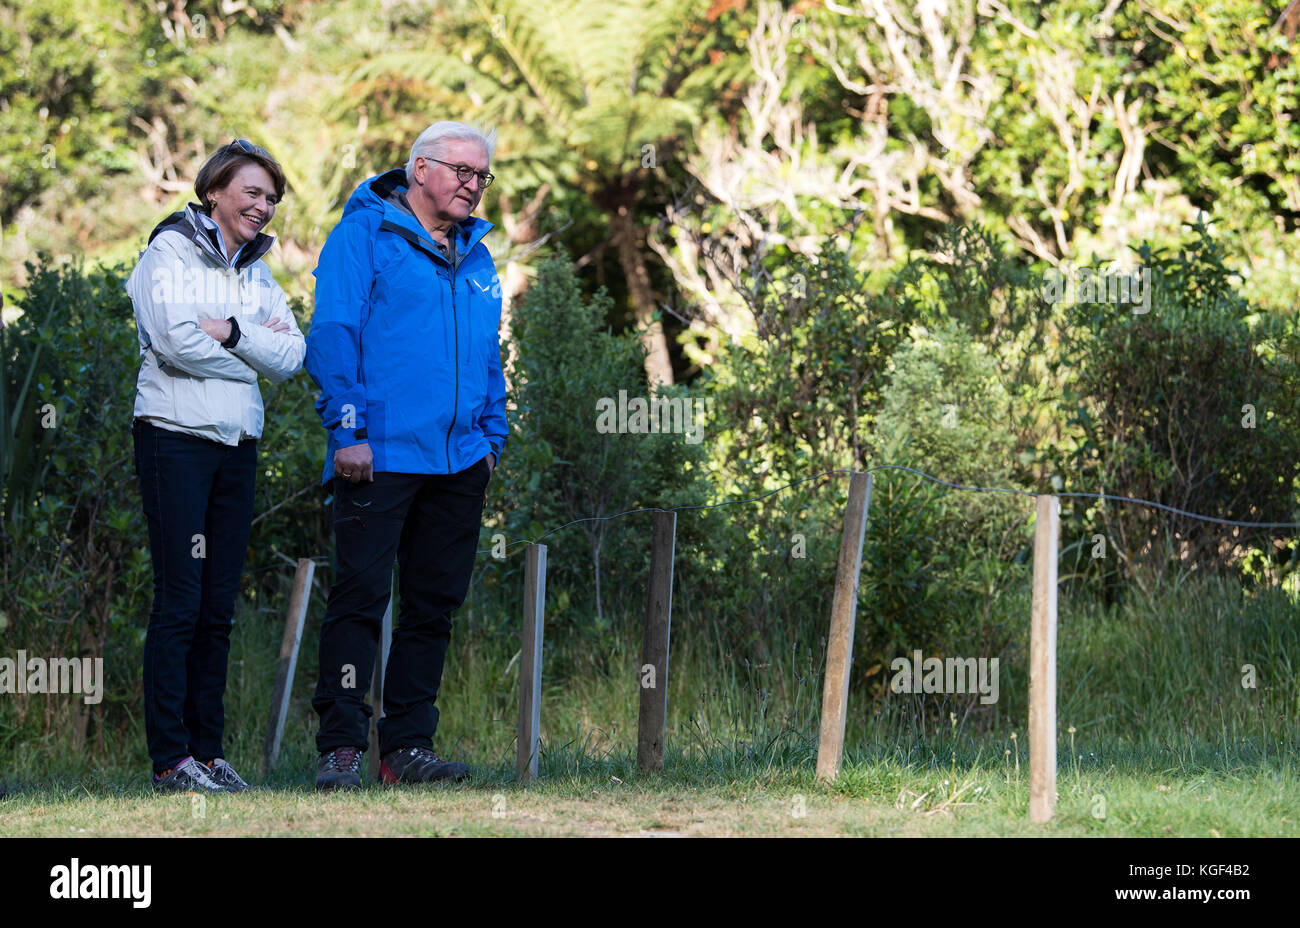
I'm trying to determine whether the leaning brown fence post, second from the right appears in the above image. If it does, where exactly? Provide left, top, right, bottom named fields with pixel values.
left=816, top=473, right=871, bottom=781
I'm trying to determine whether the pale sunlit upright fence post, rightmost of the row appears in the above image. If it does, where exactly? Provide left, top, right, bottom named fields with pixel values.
left=1030, top=494, right=1061, bottom=821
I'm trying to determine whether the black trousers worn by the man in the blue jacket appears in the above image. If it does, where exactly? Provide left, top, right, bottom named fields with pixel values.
left=312, top=458, right=490, bottom=755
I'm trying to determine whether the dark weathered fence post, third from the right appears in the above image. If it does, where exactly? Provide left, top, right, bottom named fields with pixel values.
left=637, top=512, right=677, bottom=773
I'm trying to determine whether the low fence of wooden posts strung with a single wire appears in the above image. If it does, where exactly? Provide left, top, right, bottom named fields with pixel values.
left=256, top=464, right=1300, bottom=821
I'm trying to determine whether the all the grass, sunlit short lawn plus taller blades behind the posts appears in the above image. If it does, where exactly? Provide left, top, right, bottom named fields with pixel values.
left=0, top=566, right=1300, bottom=837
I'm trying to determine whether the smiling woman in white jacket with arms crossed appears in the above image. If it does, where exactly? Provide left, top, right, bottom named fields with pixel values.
left=126, top=139, right=306, bottom=793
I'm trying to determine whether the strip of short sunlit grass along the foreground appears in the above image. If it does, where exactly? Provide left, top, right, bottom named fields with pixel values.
left=0, top=742, right=1300, bottom=837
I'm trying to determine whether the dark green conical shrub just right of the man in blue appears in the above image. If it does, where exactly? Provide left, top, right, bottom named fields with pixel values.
left=480, top=255, right=709, bottom=639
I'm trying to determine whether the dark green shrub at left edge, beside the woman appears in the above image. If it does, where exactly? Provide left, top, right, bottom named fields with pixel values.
left=0, top=256, right=152, bottom=743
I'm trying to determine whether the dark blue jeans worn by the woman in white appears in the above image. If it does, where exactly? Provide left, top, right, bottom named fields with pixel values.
left=131, top=419, right=257, bottom=773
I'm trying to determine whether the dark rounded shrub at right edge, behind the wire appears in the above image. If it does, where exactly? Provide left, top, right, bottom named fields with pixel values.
left=1057, top=218, right=1300, bottom=586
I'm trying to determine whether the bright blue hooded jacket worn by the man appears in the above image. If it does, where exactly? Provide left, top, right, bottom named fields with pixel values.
left=306, top=169, right=507, bottom=483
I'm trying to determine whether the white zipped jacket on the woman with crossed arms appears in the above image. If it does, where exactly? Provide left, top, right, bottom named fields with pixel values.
left=126, top=203, right=307, bottom=446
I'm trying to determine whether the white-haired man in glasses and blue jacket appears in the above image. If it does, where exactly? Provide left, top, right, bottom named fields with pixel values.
left=306, top=122, right=507, bottom=789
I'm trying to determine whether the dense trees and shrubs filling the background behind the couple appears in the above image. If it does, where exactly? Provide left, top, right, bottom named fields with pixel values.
left=0, top=0, right=1300, bottom=747
